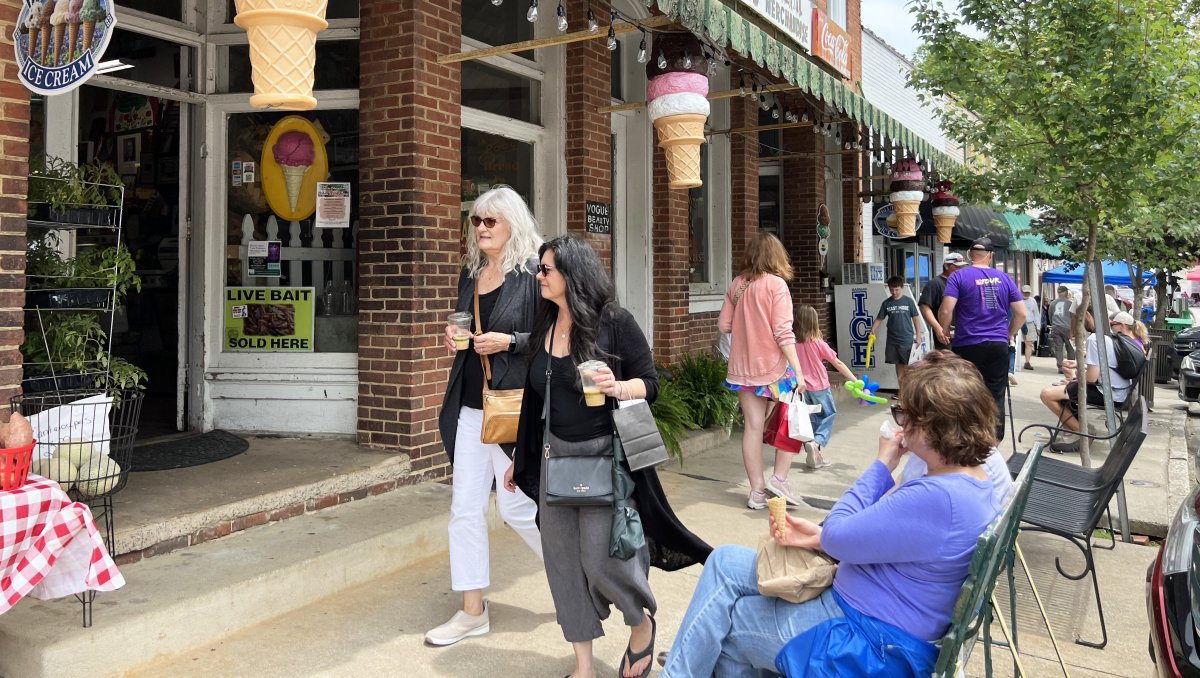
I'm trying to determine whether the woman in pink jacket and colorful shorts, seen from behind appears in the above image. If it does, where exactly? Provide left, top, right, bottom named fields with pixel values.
left=716, top=232, right=805, bottom=510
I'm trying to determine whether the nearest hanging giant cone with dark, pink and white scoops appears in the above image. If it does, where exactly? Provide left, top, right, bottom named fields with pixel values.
left=646, top=32, right=709, bottom=188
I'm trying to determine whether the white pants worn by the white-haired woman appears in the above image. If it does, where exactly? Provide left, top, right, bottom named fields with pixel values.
left=450, top=407, right=541, bottom=590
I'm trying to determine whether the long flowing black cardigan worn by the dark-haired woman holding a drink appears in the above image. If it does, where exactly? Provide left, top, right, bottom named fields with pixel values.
left=512, top=308, right=713, bottom=571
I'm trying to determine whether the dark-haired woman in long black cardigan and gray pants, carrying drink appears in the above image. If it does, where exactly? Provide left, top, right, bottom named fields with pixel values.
left=505, top=235, right=710, bottom=678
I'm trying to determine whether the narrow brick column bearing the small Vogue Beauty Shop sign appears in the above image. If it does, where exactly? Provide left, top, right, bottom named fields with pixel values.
left=566, top=0, right=622, bottom=270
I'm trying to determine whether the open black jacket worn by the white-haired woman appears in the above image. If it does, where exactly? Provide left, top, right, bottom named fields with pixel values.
left=438, top=258, right=541, bottom=463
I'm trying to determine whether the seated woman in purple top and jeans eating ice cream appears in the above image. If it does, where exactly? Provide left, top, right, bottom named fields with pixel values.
left=662, top=350, right=1001, bottom=678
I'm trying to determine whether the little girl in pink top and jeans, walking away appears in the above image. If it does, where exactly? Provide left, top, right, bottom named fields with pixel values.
left=796, top=306, right=858, bottom=469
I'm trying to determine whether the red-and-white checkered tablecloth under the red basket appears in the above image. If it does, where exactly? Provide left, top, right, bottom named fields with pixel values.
left=0, top=475, right=125, bottom=614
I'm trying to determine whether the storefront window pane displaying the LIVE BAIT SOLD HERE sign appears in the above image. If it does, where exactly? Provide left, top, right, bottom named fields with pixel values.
left=222, top=110, right=359, bottom=353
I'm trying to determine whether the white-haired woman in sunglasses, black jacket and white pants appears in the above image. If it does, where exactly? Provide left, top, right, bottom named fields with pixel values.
left=425, top=186, right=541, bottom=646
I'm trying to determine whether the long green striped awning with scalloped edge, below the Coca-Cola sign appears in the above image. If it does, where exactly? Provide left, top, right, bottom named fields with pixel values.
left=643, top=0, right=960, bottom=167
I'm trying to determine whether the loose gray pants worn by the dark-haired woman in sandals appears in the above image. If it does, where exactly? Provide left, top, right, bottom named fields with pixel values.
left=539, top=489, right=658, bottom=643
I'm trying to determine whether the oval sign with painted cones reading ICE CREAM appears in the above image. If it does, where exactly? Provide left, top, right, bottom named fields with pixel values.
left=12, top=0, right=116, bottom=95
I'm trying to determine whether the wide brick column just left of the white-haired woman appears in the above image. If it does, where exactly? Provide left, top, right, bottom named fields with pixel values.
left=358, top=0, right=462, bottom=476
